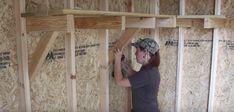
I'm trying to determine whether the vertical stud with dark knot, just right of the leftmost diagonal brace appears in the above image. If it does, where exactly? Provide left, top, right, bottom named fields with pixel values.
left=65, top=0, right=77, bottom=112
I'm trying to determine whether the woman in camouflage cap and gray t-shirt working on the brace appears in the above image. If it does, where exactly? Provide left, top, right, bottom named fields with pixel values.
left=114, top=38, right=160, bottom=112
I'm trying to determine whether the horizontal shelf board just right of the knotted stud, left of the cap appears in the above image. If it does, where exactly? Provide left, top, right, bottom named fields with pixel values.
left=75, top=17, right=122, bottom=29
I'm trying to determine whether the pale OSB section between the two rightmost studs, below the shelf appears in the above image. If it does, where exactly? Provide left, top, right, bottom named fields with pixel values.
left=181, top=28, right=212, bottom=112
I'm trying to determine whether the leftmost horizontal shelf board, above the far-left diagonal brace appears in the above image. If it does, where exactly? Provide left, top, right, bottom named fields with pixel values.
left=26, top=16, right=67, bottom=31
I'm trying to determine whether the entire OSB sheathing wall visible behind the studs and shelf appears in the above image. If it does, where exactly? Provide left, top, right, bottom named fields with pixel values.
left=0, top=0, right=234, bottom=112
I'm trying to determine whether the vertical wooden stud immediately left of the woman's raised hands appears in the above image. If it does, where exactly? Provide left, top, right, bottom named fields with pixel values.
left=98, top=0, right=109, bottom=112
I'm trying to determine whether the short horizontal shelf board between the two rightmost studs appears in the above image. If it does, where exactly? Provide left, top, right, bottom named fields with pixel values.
left=176, top=18, right=204, bottom=28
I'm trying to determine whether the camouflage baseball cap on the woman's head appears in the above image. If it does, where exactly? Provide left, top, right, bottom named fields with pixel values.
left=132, top=38, right=159, bottom=54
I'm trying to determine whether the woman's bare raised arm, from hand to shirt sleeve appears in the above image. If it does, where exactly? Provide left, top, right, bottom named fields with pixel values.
left=114, top=49, right=131, bottom=87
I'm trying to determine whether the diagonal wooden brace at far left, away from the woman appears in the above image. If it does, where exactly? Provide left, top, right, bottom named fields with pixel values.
left=29, top=32, right=59, bottom=80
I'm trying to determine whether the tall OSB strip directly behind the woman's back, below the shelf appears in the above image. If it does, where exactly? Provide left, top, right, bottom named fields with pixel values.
left=158, top=29, right=178, bottom=112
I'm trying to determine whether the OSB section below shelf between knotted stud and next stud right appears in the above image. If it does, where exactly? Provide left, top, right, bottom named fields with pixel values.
left=76, top=30, right=100, bottom=112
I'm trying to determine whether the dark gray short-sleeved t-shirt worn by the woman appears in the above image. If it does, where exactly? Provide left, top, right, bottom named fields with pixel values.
left=128, top=67, right=160, bottom=112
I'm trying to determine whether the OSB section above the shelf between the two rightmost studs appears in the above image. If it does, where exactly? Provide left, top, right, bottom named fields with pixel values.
left=185, top=0, right=215, bottom=15
